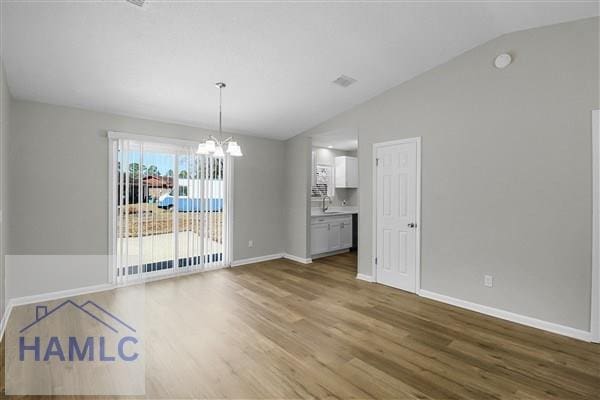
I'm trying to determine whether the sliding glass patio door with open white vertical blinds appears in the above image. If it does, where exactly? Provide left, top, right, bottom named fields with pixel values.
left=111, top=137, right=231, bottom=283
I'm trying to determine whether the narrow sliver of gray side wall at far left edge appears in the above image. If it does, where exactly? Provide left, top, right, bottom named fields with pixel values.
left=0, top=60, right=11, bottom=318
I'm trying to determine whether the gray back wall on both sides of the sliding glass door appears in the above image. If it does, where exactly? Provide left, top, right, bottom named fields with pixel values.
left=7, top=100, right=284, bottom=296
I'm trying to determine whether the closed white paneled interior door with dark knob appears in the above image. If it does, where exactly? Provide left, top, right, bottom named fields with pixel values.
left=375, top=140, right=420, bottom=293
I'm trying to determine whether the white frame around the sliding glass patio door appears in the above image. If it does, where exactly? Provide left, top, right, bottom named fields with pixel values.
left=107, top=130, right=235, bottom=285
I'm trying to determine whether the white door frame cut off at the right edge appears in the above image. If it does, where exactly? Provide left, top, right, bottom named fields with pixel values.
left=590, top=110, right=600, bottom=343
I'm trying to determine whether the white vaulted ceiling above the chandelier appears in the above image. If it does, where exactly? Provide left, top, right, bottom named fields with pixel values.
left=2, top=0, right=598, bottom=139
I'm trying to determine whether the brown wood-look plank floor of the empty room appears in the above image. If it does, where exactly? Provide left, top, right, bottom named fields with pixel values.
left=0, top=253, right=600, bottom=400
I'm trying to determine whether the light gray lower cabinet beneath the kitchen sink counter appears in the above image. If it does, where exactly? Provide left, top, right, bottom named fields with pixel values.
left=310, top=215, right=352, bottom=255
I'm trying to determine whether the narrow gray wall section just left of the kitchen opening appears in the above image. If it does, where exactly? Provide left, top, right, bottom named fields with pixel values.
left=282, top=136, right=311, bottom=258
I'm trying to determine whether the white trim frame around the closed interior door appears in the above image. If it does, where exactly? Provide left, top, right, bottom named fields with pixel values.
left=371, top=136, right=421, bottom=294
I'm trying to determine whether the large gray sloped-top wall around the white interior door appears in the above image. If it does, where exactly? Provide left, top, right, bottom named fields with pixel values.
left=306, top=18, right=600, bottom=330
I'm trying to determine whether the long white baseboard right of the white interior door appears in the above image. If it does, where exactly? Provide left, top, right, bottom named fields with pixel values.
left=418, top=289, right=592, bottom=342
